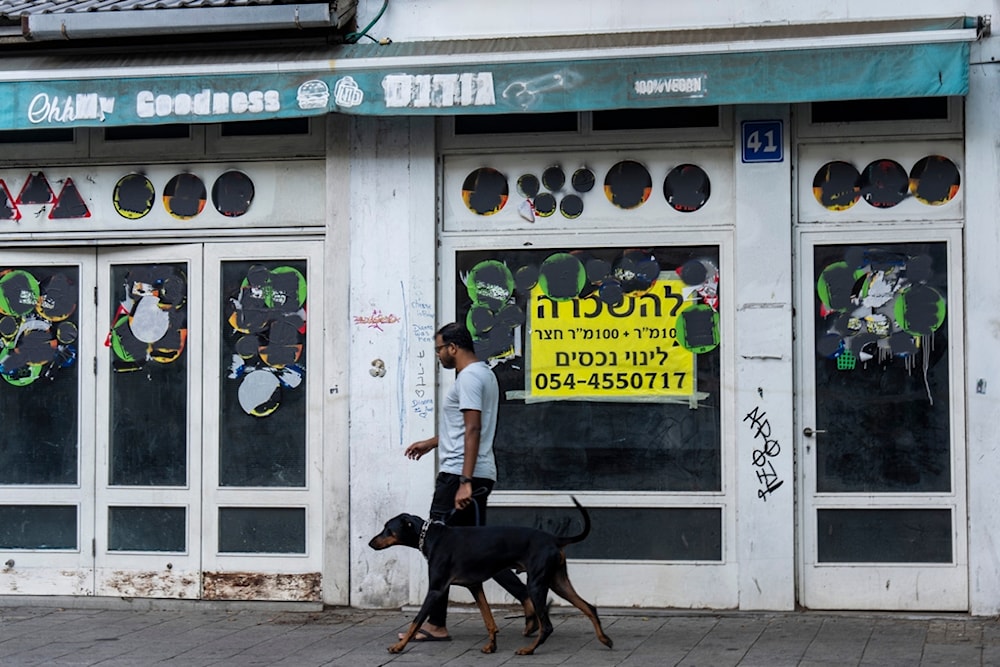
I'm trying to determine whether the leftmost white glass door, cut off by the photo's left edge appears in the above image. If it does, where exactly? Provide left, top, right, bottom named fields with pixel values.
left=0, top=250, right=95, bottom=595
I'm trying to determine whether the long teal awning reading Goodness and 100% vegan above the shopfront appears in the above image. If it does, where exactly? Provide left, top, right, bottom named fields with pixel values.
left=0, top=30, right=975, bottom=130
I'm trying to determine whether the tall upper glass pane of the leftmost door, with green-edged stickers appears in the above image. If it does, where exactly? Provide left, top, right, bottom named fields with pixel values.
left=0, top=266, right=80, bottom=486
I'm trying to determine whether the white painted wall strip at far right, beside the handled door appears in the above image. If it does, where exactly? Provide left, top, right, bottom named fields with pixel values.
left=960, top=37, right=1000, bottom=616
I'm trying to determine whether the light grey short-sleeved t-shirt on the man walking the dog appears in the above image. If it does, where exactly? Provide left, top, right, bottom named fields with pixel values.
left=438, top=361, right=500, bottom=481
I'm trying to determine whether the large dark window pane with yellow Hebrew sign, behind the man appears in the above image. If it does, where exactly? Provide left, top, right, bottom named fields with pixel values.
left=455, top=246, right=722, bottom=491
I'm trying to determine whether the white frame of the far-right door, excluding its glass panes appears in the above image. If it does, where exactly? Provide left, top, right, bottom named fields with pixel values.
left=795, top=222, right=969, bottom=611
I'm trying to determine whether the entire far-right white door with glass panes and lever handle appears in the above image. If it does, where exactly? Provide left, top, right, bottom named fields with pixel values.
left=797, top=229, right=968, bottom=610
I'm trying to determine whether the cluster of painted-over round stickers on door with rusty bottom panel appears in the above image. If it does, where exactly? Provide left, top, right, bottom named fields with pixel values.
left=225, top=264, right=306, bottom=417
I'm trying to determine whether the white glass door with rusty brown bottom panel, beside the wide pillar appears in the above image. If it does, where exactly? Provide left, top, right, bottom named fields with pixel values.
left=202, top=242, right=324, bottom=601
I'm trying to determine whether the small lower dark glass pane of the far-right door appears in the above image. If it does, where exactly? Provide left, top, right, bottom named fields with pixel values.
left=816, top=509, right=952, bottom=563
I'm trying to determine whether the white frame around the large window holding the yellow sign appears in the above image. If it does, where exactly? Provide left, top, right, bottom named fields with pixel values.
left=442, top=229, right=739, bottom=609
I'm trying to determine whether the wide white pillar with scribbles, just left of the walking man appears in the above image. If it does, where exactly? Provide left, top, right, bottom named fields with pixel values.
left=344, top=117, right=437, bottom=607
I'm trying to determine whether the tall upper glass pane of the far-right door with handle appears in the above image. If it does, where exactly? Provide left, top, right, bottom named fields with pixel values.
left=814, top=243, right=951, bottom=493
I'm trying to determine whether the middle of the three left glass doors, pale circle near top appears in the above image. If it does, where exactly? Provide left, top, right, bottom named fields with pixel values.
left=95, top=245, right=203, bottom=598
